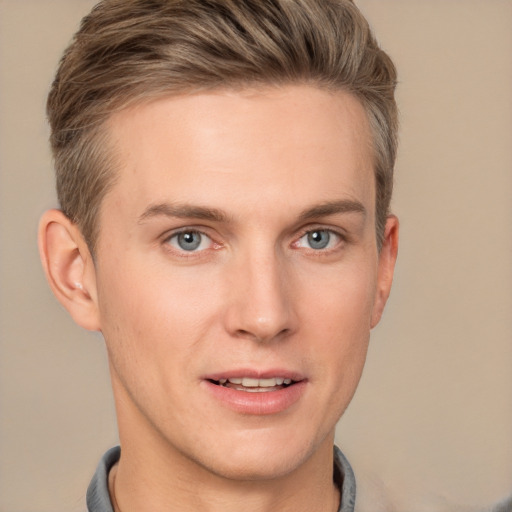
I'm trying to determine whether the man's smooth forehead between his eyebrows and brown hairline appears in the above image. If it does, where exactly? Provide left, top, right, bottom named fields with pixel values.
left=102, top=86, right=374, bottom=224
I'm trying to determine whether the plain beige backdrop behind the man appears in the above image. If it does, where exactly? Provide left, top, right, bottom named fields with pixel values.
left=0, top=0, right=512, bottom=512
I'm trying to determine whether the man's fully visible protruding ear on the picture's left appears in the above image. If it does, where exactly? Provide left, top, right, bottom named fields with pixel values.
left=38, top=210, right=100, bottom=331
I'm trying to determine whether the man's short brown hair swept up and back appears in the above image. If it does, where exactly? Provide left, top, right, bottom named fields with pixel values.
left=47, top=0, right=398, bottom=251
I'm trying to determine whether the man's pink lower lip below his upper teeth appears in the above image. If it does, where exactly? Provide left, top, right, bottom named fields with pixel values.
left=203, top=380, right=306, bottom=416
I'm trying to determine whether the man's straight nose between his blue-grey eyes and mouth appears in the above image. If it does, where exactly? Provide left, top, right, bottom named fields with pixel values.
left=225, top=246, right=297, bottom=342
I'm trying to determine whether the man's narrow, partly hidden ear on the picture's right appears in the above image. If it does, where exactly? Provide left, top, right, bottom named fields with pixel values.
left=371, top=215, right=398, bottom=329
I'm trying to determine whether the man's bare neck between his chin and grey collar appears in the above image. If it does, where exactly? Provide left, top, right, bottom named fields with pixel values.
left=109, top=428, right=340, bottom=512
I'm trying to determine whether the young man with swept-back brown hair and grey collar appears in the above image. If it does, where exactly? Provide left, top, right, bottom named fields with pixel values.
left=40, top=0, right=398, bottom=512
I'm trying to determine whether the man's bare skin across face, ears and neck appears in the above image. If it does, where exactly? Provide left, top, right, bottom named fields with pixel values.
left=40, top=86, right=398, bottom=512
